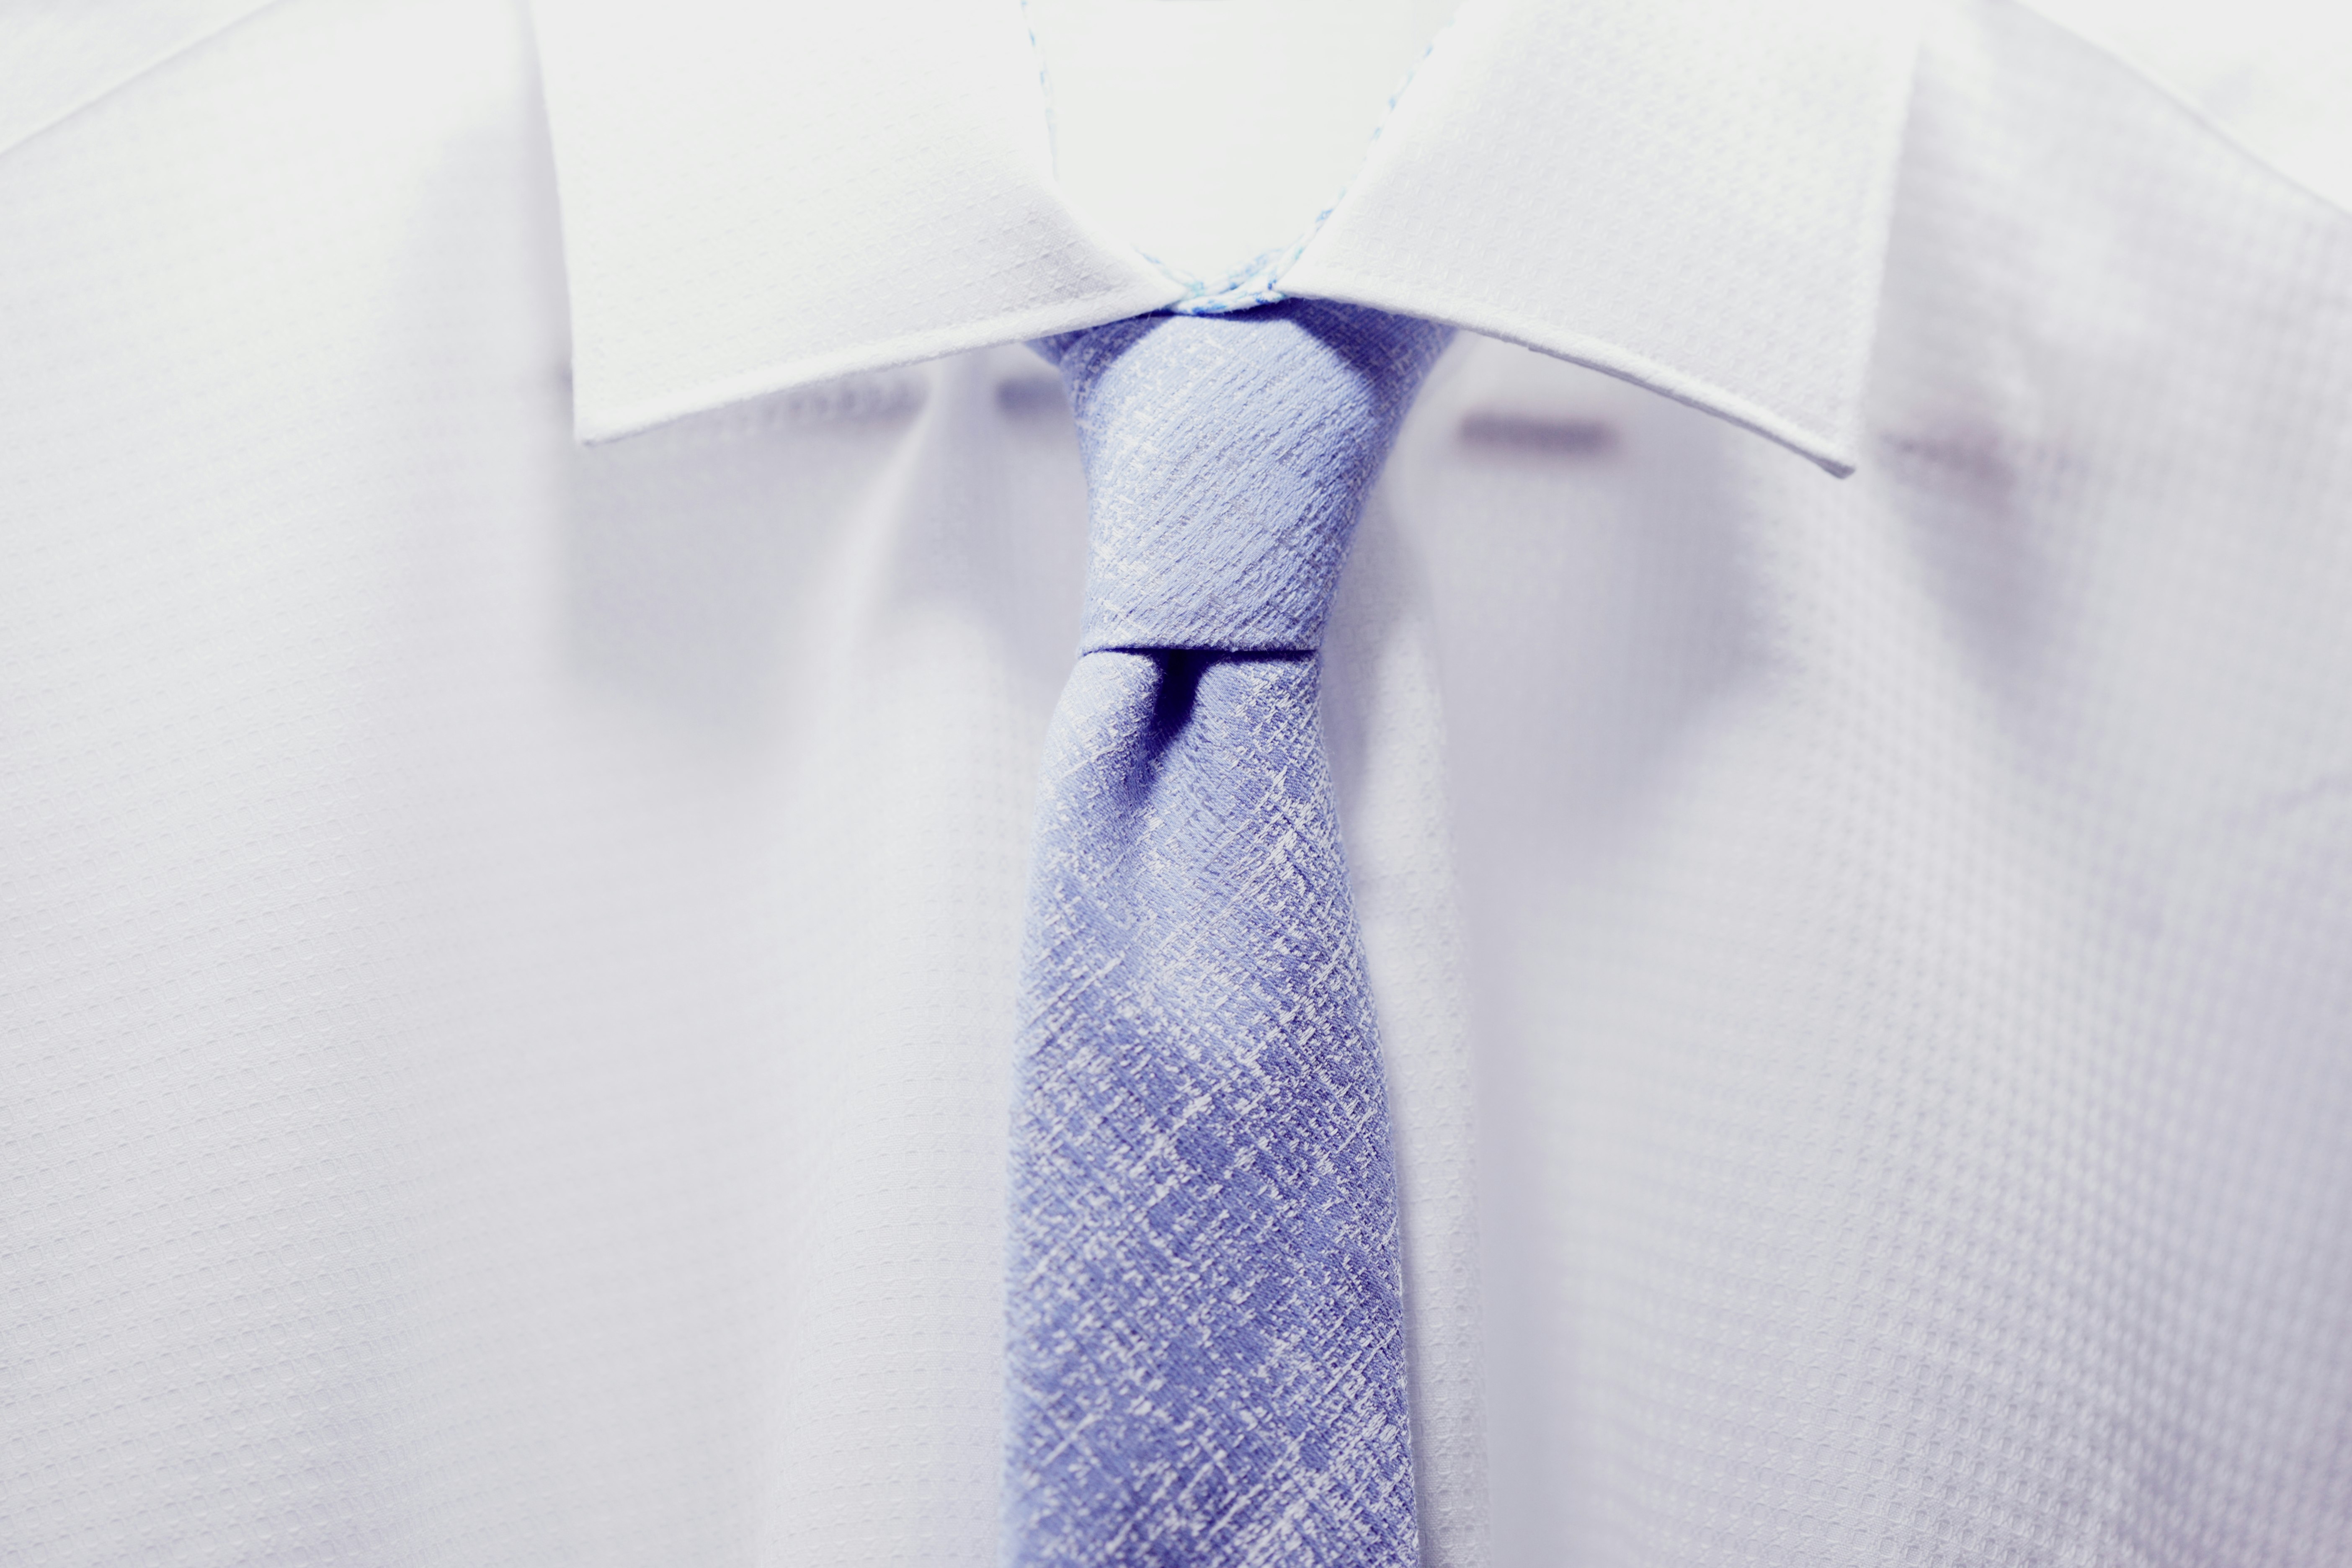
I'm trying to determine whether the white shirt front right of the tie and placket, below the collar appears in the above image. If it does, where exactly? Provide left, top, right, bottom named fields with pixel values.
left=1390, top=5, right=2352, bottom=1568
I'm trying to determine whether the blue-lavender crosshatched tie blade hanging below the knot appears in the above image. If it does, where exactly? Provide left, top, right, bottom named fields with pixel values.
left=1007, top=653, right=1416, bottom=1565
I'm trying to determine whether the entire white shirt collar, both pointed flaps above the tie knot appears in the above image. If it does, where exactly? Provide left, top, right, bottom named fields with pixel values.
left=536, top=0, right=1917, bottom=472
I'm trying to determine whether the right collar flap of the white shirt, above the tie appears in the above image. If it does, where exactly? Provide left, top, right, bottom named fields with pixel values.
left=1282, top=0, right=1917, bottom=472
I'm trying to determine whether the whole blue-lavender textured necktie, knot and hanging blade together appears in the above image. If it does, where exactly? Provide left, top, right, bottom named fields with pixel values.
left=1007, top=301, right=1449, bottom=1568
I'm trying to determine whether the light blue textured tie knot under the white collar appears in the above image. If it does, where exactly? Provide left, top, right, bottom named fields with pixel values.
left=1037, top=301, right=1451, bottom=653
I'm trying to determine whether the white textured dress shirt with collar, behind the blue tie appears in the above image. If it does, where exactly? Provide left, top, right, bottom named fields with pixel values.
left=0, top=0, right=2352, bottom=1568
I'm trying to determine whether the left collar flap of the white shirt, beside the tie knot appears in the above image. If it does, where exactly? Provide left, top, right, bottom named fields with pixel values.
left=539, top=0, right=1183, bottom=440
